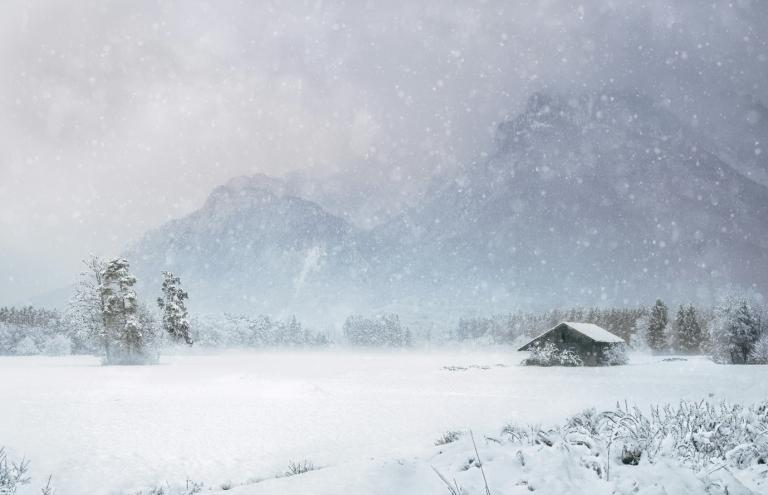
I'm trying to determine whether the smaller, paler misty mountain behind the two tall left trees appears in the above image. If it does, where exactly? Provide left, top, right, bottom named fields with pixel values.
left=126, top=176, right=366, bottom=320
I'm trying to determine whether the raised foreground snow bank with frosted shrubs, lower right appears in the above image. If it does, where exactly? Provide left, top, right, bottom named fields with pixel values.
left=216, top=401, right=768, bottom=495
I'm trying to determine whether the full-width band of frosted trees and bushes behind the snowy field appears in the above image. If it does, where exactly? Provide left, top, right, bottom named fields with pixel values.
left=0, top=280, right=768, bottom=366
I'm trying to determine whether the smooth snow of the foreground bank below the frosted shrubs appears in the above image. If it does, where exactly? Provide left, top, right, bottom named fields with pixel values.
left=219, top=438, right=768, bottom=495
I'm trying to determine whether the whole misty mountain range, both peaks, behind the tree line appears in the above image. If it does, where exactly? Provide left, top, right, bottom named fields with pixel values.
left=128, top=92, right=768, bottom=318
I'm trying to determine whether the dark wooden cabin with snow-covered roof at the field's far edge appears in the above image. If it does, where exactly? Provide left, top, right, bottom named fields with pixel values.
left=518, top=321, right=624, bottom=366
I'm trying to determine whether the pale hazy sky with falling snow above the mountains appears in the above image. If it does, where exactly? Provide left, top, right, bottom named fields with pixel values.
left=0, top=0, right=768, bottom=305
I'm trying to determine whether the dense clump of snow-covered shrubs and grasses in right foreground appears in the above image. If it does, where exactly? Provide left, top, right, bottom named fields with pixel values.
left=502, top=401, right=768, bottom=493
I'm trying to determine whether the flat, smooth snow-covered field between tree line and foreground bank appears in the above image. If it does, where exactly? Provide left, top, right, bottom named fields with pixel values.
left=0, top=347, right=768, bottom=495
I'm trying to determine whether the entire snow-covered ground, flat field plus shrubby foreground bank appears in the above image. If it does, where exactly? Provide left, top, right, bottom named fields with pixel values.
left=0, top=354, right=768, bottom=495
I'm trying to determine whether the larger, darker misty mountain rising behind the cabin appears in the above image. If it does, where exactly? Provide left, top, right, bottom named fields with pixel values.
left=368, top=93, right=768, bottom=304
